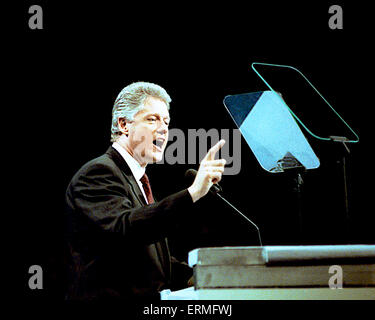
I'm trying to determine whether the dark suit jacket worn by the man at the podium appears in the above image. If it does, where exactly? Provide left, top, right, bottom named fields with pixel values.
left=66, top=147, right=193, bottom=299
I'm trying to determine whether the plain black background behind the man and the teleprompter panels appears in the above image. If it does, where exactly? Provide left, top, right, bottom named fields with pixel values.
left=7, top=1, right=375, bottom=308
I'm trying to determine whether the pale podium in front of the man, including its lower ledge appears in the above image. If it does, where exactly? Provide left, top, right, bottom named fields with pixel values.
left=189, top=245, right=375, bottom=300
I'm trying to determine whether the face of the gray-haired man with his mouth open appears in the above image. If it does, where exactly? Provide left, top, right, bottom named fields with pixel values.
left=126, top=97, right=170, bottom=166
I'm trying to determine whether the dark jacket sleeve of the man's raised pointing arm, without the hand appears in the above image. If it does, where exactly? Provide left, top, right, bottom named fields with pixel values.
left=67, top=164, right=193, bottom=243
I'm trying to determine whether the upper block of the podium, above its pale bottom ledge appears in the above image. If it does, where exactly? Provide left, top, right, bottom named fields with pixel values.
left=189, top=245, right=375, bottom=289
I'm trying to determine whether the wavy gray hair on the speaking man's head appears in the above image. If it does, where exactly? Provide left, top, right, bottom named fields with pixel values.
left=111, top=82, right=172, bottom=142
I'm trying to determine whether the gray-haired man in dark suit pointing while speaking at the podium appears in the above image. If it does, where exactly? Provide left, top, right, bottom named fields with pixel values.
left=66, top=82, right=225, bottom=299
